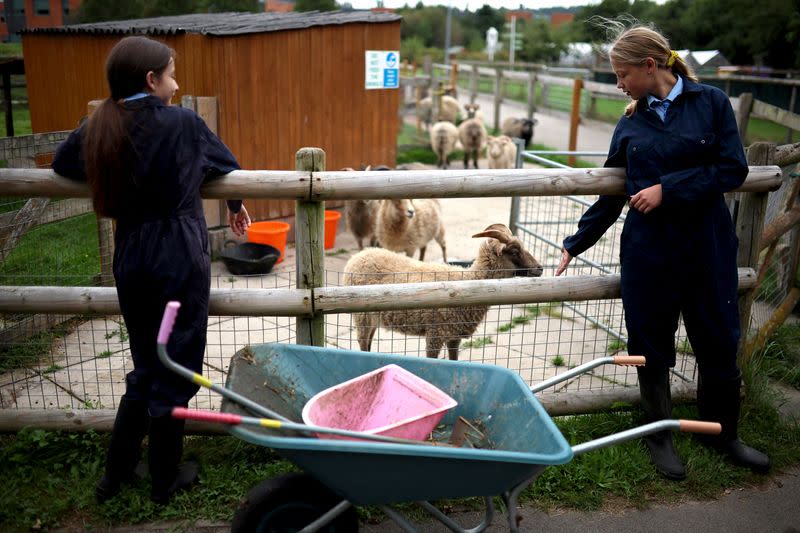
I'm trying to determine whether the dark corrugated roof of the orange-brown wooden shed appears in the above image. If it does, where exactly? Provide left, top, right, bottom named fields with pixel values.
left=24, top=11, right=402, bottom=36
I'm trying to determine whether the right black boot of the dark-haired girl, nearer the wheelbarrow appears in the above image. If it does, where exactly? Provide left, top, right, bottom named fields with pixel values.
left=148, top=416, right=199, bottom=505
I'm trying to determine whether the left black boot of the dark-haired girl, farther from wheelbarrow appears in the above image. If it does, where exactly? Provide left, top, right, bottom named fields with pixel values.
left=95, top=396, right=150, bottom=503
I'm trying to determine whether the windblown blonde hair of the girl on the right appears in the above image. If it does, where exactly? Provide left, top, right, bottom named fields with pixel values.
left=591, top=17, right=698, bottom=116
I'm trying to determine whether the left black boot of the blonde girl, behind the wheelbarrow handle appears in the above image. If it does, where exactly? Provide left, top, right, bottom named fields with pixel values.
left=636, top=367, right=686, bottom=481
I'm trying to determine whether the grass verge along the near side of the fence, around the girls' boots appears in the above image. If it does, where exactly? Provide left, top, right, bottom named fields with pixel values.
left=0, top=338, right=800, bottom=531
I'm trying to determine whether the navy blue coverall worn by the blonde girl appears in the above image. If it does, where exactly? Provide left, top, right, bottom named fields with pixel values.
left=564, top=78, right=747, bottom=381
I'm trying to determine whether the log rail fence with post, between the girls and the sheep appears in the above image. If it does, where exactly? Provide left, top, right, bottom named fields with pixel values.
left=0, top=148, right=782, bottom=431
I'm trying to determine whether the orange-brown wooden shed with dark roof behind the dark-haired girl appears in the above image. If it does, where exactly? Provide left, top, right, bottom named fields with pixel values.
left=22, top=11, right=401, bottom=222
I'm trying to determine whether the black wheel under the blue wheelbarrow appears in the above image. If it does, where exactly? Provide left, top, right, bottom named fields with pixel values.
left=231, top=474, right=358, bottom=533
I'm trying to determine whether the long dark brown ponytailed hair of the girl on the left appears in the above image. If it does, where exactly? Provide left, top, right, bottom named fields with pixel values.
left=83, top=36, right=175, bottom=218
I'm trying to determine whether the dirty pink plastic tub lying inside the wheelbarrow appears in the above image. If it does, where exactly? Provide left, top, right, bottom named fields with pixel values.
left=303, top=365, right=457, bottom=440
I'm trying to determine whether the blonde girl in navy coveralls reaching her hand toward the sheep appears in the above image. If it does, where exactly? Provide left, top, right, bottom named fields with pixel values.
left=555, top=19, right=770, bottom=480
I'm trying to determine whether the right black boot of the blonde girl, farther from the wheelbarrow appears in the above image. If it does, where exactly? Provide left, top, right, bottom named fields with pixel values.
left=697, top=375, right=772, bottom=474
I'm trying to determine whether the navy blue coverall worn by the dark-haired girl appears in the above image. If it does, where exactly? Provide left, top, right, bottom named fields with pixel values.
left=53, top=96, right=241, bottom=417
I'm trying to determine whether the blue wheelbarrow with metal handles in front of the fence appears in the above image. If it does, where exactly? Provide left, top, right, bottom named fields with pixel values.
left=158, top=303, right=721, bottom=533
